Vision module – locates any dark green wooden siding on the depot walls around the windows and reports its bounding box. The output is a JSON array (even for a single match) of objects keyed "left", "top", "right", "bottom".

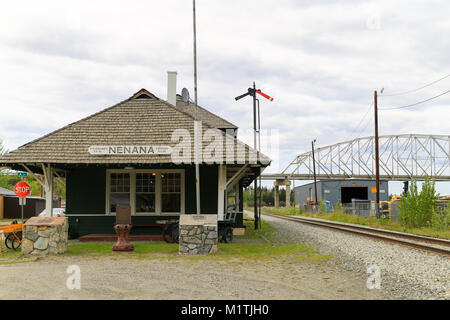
[{"left": 66, "top": 165, "right": 244, "bottom": 238}]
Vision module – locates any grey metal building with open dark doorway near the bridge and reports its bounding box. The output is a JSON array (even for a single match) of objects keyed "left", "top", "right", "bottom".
[{"left": 294, "top": 179, "right": 389, "bottom": 207}]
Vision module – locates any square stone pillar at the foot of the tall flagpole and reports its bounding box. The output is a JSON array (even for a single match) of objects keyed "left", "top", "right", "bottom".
[{"left": 179, "top": 214, "right": 219, "bottom": 255}]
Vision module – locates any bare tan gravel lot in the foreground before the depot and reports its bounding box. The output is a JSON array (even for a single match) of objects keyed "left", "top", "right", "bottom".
[{"left": 0, "top": 253, "right": 383, "bottom": 300}]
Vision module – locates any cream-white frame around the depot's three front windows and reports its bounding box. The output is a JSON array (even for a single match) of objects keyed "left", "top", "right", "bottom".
[{"left": 105, "top": 169, "right": 185, "bottom": 216}]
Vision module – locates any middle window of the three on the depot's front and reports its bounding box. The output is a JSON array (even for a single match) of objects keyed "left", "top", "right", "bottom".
[{"left": 136, "top": 172, "right": 156, "bottom": 212}]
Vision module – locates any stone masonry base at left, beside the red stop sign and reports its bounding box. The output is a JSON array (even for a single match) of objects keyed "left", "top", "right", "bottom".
[{"left": 22, "top": 217, "right": 69, "bottom": 255}]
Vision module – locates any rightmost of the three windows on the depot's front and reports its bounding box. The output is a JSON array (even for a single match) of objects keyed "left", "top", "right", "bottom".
[{"left": 161, "top": 173, "right": 181, "bottom": 212}]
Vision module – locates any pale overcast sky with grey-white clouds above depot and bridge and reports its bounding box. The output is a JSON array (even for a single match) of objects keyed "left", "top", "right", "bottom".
[{"left": 0, "top": 0, "right": 450, "bottom": 193}]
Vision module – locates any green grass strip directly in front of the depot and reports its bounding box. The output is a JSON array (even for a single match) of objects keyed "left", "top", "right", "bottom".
[{"left": 0, "top": 219, "right": 331, "bottom": 264}]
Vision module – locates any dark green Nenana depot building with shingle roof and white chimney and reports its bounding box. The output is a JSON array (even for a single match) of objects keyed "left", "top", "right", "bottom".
[{"left": 0, "top": 72, "right": 270, "bottom": 238}]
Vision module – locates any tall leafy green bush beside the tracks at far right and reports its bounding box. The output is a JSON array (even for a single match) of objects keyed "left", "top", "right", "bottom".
[{"left": 399, "top": 178, "right": 439, "bottom": 228}]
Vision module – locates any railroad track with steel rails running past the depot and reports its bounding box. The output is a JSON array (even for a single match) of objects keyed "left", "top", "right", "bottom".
[{"left": 261, "top": 212, "right": 450, "bottom": 256}]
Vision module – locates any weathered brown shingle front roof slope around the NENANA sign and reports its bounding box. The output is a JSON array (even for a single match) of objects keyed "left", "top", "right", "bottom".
[{"left": 0, "top": 89, "right": 270, "bottom": 166}]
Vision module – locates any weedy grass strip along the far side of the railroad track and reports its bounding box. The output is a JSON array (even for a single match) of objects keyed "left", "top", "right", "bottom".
[{"left": 263, "top": 208, "right": 450, "bottom": 239}]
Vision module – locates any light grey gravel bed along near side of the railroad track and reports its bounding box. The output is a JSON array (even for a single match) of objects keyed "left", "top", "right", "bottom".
[{"left": 263, "top": 212, "right": 450, "bottom": 300}]
